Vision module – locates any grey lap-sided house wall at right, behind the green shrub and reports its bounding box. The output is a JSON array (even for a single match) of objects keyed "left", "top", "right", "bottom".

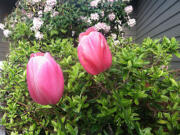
[{"left": 136, "top": 0, "right": 180, "bottom": 69}]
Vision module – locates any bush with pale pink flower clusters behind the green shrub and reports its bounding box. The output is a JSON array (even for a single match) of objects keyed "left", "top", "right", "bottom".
[{"left": 0, "top": 0, "right": 136, "bottom": 43}]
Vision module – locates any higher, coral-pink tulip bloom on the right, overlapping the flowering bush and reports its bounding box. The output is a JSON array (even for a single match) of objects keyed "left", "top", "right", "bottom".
[{"left": 78, "top": 27, "right": 112, "bottom": 75}]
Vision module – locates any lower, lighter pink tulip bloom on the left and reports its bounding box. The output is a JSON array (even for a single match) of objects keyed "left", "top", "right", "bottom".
[{"left": 27, "top": 52, "right": 64, "bottom": 105}]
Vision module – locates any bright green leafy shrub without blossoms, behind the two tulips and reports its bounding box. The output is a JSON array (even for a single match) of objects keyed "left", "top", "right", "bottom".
[{"left": 0, "top": 38, "right": 180, "bottom": 135}]
